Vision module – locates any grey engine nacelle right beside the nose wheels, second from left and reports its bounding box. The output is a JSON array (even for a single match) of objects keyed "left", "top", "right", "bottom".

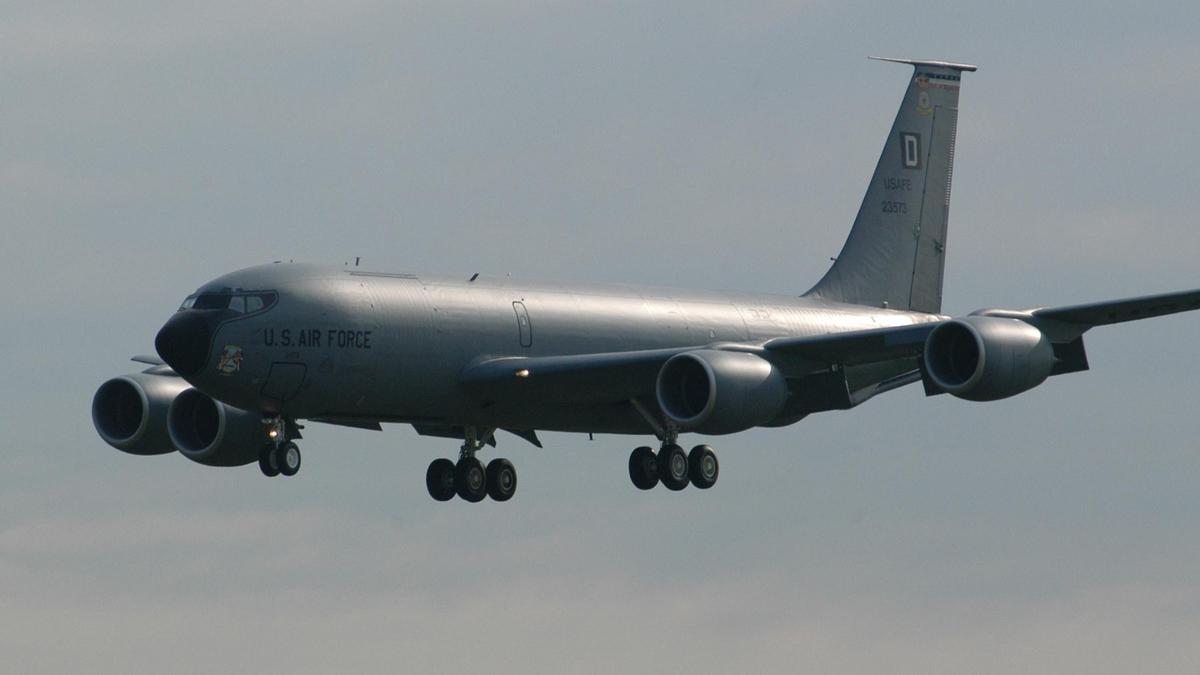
[{"left": 167, "top": 389, "right": 269, "bottom": 466}]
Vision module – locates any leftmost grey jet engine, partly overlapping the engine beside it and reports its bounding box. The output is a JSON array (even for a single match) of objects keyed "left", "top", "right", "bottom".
[{"left": 91, "top": 369, "right": 187, "bottom": 455}]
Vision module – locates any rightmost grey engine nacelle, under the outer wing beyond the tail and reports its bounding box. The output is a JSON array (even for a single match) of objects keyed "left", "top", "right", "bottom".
[{"left": 925, "top": 316, "right": 1055, "bottom": 401}]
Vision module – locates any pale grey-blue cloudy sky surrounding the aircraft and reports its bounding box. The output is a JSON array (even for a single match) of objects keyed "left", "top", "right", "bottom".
[{"left": 0, "top": 0, "right": 1200, "bottom": 674}]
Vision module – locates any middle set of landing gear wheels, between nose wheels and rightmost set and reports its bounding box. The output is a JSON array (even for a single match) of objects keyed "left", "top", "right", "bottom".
[{"left": 425, "top": 426, "right": 517, "bottom": 502}]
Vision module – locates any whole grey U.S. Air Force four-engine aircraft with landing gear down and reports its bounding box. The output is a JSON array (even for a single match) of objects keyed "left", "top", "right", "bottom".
[{"left": 92, "top": 59, "right": 1200, "bottom": 502}]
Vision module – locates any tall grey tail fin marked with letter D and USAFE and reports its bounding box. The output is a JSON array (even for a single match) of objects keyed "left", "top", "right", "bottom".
[{"left": 806, "top": 59, "right": 976, "bottom": 312}]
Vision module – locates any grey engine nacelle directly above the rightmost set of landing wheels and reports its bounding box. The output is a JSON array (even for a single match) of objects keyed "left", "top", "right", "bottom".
[{"left": 655, "top": 350, "right": 787, "bottom": 434}]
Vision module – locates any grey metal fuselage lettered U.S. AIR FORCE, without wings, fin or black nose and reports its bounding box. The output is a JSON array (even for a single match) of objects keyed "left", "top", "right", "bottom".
[{"left": 169, "top": 263, "right": 944, "bottom": 434}]
